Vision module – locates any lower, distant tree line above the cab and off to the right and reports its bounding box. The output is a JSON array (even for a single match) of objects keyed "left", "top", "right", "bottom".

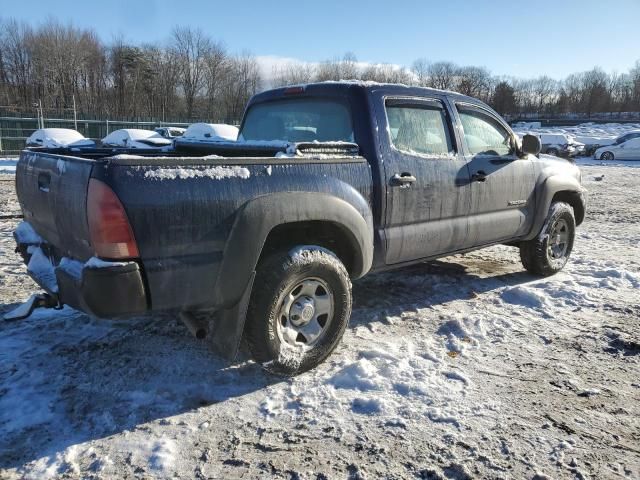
[{"left": 274, "top": 53, "right": 640, "bottom": 115}]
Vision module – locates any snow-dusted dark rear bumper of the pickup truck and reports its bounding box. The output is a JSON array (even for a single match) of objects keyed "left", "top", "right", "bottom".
[{"left": 16, "top": 234, "right": 148, "bottom": 318}]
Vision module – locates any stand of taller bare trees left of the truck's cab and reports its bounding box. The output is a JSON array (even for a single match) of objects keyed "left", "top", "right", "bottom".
[{"left": 0, "top": 19, "right": 262, "bottom": 121}]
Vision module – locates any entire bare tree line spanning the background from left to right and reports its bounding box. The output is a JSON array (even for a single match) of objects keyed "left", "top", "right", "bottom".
[{"left": 0, "top": 19, "right": 640, "bottom": 121}]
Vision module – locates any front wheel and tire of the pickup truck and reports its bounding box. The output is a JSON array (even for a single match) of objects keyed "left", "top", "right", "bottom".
[{"left": 520, "top": 202, "right": 576, "bottom": 277}]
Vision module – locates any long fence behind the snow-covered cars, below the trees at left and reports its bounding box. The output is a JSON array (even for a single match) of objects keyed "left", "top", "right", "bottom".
[{"left": 0, "top": 116, "right": 240, "bottom": 155}]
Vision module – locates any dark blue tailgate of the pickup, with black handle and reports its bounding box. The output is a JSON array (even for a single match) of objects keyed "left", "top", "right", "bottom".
[{"left": 16, "top": 150, "right": 99, "bottom": 260}]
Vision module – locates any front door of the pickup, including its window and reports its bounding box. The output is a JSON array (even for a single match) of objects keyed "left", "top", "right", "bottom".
[{"left": 456, "top": 103, "right": 536, "bottom": 247}]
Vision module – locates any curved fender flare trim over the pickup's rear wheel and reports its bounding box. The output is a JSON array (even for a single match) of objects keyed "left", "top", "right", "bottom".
[{"left": 215, "top": 192, "right": 373, "bottom": 308}]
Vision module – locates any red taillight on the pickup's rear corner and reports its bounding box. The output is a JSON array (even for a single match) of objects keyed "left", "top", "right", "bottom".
[{"left": 87, "top": 178, "right": 139, "bottom": 259}]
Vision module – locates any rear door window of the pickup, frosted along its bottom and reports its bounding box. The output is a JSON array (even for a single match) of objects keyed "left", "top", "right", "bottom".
[{"left": 386, "top": 103, "right": 455, "bottom": 156}]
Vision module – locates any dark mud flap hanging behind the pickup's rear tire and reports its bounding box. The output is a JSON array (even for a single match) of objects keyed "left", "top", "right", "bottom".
[{"left": 209, "top": 271, "right": 256, "bottom": 361}]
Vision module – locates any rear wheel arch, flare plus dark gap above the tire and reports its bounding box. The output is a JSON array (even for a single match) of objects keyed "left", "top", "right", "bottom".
[{"left": 215, "top": 192, "right": 373, "bottom": 308}]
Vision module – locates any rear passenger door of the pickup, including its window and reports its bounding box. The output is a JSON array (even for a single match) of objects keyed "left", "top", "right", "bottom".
[{"left": 380, "top": 97, "right": 471, "bottom": 264}]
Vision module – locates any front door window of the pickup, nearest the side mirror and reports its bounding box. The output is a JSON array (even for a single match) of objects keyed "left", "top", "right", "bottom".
[{"left": 458, "top": 106, "right": 513, "bottom": 156}]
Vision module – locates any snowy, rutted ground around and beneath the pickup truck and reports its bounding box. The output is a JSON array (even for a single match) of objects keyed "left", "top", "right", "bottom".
[{"left": 0, "top": 160, "right": 640, "bottom": 479}]
